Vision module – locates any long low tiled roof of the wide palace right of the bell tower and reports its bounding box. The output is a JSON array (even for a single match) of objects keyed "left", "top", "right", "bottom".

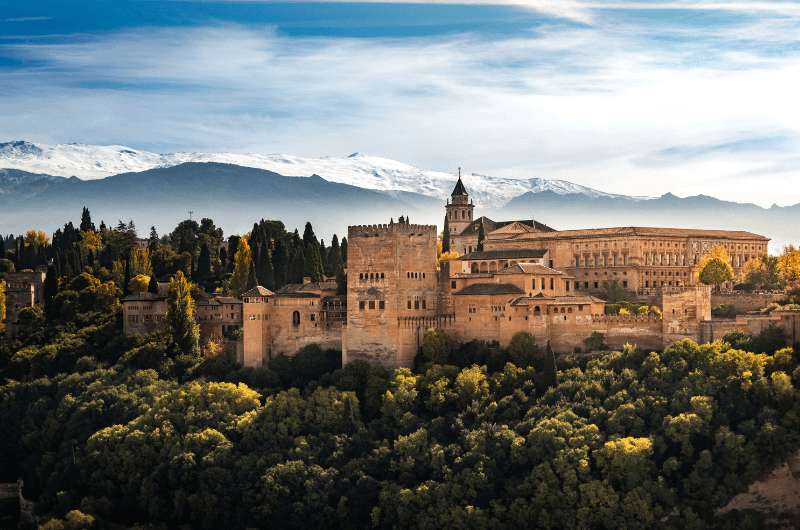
[{"left": 512, "top": 226, "right": 769, "bottom": 241}]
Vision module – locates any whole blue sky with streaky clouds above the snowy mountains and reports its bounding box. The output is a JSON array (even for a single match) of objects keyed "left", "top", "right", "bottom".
[{"left": 0, "top": 0, "right": 800, "bottom": 205}]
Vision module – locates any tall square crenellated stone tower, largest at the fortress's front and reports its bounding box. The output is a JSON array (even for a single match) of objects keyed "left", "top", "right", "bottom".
[{"left": 342, "top": 223, "right": 438, "bottom": 368}]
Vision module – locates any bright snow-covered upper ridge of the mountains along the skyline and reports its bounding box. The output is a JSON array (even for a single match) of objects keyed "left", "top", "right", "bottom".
[{"left": 0, "top": 141, "right": 640, "bottom": 207}]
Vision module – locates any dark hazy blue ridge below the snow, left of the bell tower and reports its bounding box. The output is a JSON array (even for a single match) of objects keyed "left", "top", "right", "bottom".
[{"left": 0, "top": 162, "right": 441, "bottom": 237}]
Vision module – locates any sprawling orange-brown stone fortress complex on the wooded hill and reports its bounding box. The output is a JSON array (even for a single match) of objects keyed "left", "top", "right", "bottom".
[{"left": 111, "top": 177, "right": 800, "bottom": 367}]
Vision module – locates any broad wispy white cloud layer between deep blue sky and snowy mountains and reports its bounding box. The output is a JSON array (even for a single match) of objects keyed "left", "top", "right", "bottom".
[{"left": 0, "top": 11, "right": 800, "bottom": 204}]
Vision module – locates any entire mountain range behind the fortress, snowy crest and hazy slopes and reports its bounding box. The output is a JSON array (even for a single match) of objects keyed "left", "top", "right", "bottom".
[{"left": 0, "top": 141, "right": 800, "bottom": 251}]
